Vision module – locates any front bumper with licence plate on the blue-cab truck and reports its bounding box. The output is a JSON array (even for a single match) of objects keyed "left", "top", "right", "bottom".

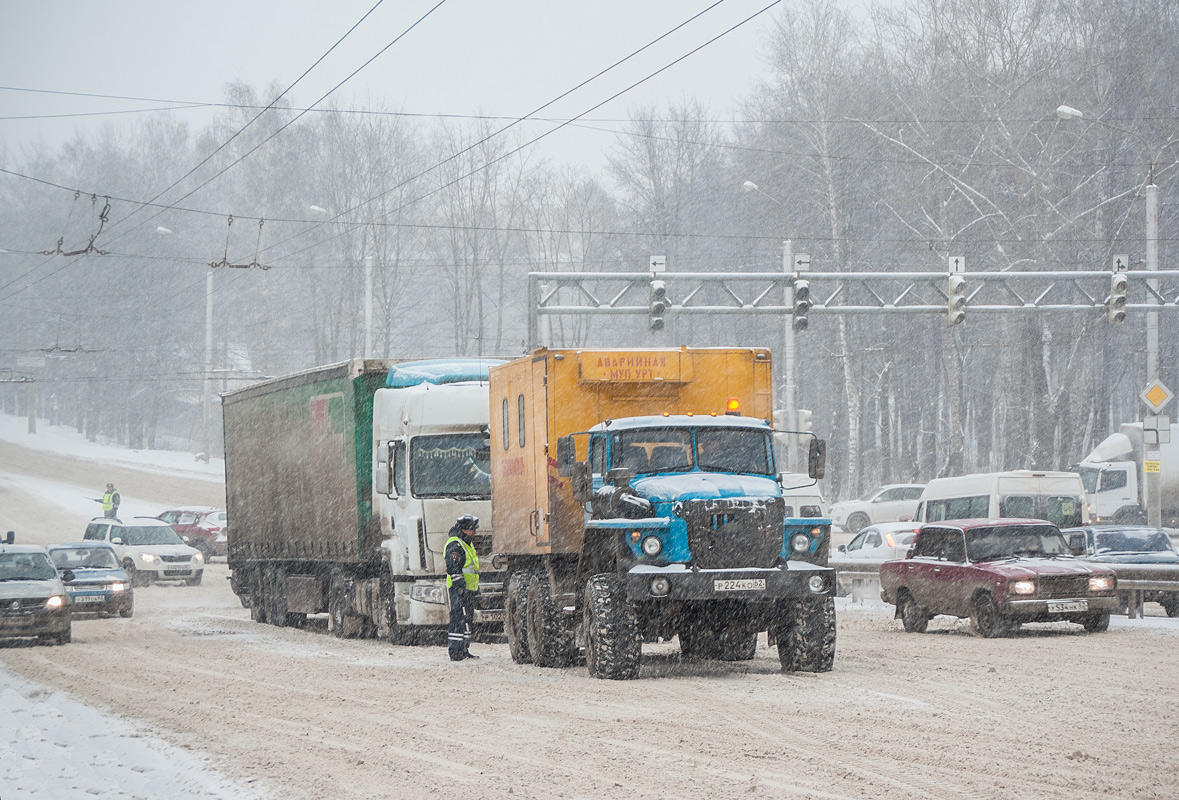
[{"left": 626, "top": 561, "right": 835, "bottom": 602}]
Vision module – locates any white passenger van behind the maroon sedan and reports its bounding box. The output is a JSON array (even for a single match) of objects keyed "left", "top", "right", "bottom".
[{"left": 914, "top": 469, "right": 1089, "bottom": 528}]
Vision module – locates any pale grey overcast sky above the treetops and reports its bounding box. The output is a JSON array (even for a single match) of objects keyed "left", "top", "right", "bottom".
[{"left": 0, "top": 0, "right": 788, "bottom": 166}]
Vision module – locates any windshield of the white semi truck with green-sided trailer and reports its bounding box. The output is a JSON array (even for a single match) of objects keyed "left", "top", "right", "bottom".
[{"left": 409, "top": 432, "right": 492, "bottom": 500}]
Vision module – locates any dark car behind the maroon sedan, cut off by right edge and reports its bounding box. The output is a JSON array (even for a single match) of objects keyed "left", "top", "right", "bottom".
[{"left": 1063, "top": 525, "right": 1179, "bottom": 616}]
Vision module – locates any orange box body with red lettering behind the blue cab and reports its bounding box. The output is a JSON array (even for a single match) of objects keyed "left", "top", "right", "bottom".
[{"left": 490, "top": 348, "right": 773, "bottom": 555}]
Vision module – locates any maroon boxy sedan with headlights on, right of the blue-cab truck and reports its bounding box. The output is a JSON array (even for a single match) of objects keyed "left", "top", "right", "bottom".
[{"left": 881, "top": 518, "right": 1118, "bottom": 639}]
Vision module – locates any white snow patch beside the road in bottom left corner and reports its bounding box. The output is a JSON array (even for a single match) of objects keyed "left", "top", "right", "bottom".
[{"left": 0, "top": 668, "right": 259, "bottom": 800}]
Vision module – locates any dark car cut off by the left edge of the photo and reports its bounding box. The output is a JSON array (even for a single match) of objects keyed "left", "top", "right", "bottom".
[{"left": 0, "top": 531, "right": 73, "bottom": 644}]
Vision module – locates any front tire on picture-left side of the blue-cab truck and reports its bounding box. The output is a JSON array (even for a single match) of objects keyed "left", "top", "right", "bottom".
[{"left": 582, "top": 574, "right": 643, "bottom": 680}]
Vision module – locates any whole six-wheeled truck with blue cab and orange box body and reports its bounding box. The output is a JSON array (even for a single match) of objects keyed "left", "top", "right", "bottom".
[{"left": 490, "top": 348, "right": 836, "bottom": 679}]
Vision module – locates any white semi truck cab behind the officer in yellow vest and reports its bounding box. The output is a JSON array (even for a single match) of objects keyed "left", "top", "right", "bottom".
[{"left": 373, "top": 358, "right": 502, "bottom": 627}]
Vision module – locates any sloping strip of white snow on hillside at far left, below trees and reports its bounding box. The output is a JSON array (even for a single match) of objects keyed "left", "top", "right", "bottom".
[{"left": 0, "top": 414, "right": 225, "bottom": 483}]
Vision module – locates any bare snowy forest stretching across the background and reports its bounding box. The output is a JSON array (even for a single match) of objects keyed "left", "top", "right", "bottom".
[{"left": 0, "top": 0, "right": 1179, "bottom": 500}]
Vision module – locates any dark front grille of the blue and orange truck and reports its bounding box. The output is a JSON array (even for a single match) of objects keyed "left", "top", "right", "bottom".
[{"left": 680, "top": 497, "right": 783, "bottom": 569}]
